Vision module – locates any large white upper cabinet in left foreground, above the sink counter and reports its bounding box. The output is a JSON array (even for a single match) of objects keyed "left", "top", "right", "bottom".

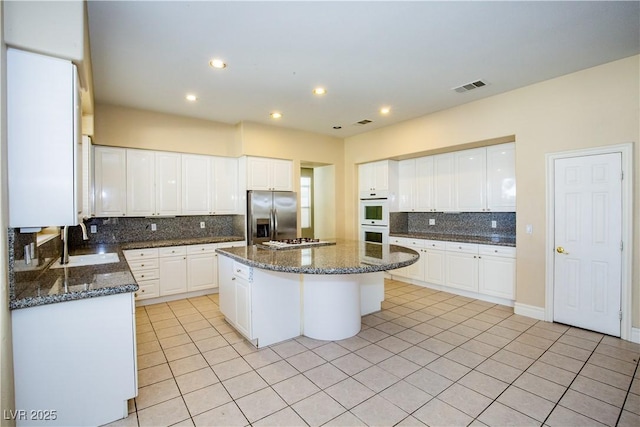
[{"left": 7, "top": 49, "right": 82, "bottom": 228}]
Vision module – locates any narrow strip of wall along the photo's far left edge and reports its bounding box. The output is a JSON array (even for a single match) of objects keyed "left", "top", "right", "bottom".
[{"left": 0, "top": 2, "right": 15, "bottom": 426}]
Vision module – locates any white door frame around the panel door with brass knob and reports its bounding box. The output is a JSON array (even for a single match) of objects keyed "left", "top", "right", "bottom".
[{"left": 544, "top": 142, "right": 634, "bottom": 341}]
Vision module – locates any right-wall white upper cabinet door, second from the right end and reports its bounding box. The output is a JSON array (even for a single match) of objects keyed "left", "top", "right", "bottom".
[{"left": 455, "top": 147, "right": 487, "bottom": 212}]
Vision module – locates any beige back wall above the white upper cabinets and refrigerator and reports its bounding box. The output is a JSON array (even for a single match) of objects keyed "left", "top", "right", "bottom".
[{"left": 93, "top": 104, "right": 345, "bottom": 236}]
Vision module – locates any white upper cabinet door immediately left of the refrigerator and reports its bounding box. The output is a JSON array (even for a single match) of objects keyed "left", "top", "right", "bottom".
[{"left": 211, "top": 157, "right": 239, "bottom": 214}]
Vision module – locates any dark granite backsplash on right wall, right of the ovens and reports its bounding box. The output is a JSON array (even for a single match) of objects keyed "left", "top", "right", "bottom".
[{"left": 389, "top": 212, "right": 516, "bottom": 237}]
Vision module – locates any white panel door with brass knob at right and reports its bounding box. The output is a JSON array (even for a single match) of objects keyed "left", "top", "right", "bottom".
[{"left": 553, "top": 153, "right": 622, "bottom": 337}]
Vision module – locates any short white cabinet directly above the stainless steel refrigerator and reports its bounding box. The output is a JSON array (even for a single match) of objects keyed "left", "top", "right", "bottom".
[{"left": 246, "top": 157, "right": 293, "bottom": 191}]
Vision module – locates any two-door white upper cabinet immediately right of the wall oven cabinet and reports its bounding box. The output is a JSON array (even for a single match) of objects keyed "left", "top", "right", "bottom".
[{"left": 398, "top": 156, "right": 435, "bottom": 212}]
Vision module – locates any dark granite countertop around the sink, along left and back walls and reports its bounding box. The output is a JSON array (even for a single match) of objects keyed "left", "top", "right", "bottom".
[{"left": 9, "top": 236, "right": 244, "bottom": 310}]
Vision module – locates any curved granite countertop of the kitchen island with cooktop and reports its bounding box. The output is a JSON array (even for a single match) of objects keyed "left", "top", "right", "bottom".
[{"left": 216, "top": 240, "right": 420, "bottom": 274}]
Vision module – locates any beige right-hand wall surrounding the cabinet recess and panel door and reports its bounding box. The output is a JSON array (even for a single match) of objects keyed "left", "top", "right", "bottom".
[{"left": 345, "top": 56, "right": 640, "bottom": 327}]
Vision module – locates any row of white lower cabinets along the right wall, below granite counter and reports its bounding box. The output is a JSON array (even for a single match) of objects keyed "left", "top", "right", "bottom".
[{"left": 389, "top": 237, "right": 516, "bottom": 302}]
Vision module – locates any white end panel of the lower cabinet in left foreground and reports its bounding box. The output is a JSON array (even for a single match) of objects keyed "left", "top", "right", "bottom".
[{"left": 11, "top": 293, "right": 138, "bottom": 426}]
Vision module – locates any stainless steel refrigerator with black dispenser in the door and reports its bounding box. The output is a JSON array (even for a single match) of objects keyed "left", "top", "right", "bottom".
[{"left": 247, "top": 190, "right": 298, "bottom": 246}]
